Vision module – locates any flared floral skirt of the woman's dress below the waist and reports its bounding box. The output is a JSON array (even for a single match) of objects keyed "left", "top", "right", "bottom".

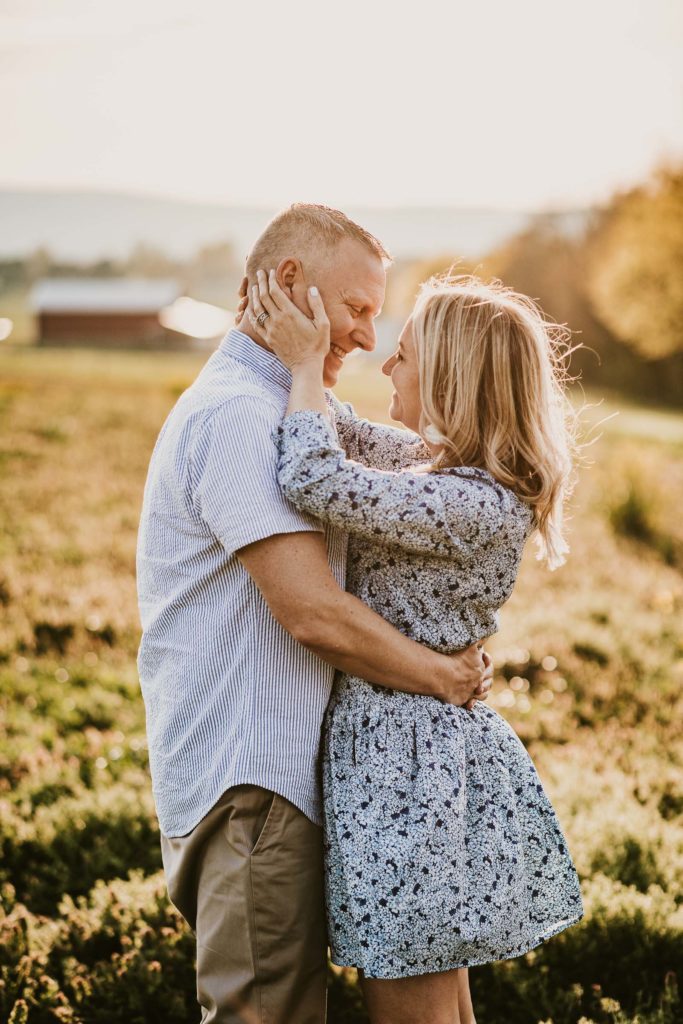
[{"left": 323, "top": 676, "right": 583, "bottom": 978}]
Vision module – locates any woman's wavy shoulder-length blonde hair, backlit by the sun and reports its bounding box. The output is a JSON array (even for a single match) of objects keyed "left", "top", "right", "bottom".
[{"left": 412, "top": 273, "right": 578, "bottom": 568}]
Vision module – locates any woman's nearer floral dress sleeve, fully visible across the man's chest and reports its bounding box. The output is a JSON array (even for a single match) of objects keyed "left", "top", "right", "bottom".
[{"left": 276, "top": 411, "right": 511, "bottom": 558}]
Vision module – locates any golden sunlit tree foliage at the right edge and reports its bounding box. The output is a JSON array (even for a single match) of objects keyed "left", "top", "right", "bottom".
[{"left": 587, "top": 167, "right": 683, "bottom": 359}]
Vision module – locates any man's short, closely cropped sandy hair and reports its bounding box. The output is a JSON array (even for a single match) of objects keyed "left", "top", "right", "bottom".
[{"left": 247, "top": 203, "right": 391, "bottom": 278}]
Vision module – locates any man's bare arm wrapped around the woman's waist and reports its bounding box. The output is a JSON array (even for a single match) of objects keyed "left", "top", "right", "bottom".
[{"left": 238, "top": 532, "right": 493, "bottom": 705}]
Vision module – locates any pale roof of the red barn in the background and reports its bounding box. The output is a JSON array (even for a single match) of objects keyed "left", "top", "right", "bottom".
[{"left": 31, "top": 278, "right": 180, "bottom": 313}]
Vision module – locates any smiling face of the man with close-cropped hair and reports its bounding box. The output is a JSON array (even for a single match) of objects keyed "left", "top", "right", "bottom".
[{"left": 292, "top": 239, "right": 386, "bottom": 387}]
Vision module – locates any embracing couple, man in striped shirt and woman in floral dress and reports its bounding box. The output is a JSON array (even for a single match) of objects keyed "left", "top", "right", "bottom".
[{"left": 137, "top": 204, "right": 583, "bottom": 1024}]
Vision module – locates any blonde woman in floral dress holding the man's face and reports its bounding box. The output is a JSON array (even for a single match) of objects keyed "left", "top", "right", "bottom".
[{"left": 251, "top": 272, "right": 583, "bottom": 1024}]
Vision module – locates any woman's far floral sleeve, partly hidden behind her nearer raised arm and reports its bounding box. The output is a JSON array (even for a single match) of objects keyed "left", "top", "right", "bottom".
[{"left": 328, "top": 391, "right": 430, "bottom": 470}]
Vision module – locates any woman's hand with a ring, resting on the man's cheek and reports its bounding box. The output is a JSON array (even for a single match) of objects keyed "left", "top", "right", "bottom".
[{"left": 248, "top": 270, "right": 330, "bottom": 375}]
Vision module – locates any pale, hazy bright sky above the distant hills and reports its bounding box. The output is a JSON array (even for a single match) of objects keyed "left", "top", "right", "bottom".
[{"left": 0, "top": 0, "right": 683, "bottom": 210}]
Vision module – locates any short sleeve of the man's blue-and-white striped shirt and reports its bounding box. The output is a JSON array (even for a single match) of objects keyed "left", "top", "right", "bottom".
[{"left": 190, "top": 395, "right": 323, "bottom": 554}]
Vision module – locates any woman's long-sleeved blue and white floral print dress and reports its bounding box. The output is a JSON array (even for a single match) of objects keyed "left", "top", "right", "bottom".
[{"left": 276, "top": 402, "right": 583, "bottom": 978}]
